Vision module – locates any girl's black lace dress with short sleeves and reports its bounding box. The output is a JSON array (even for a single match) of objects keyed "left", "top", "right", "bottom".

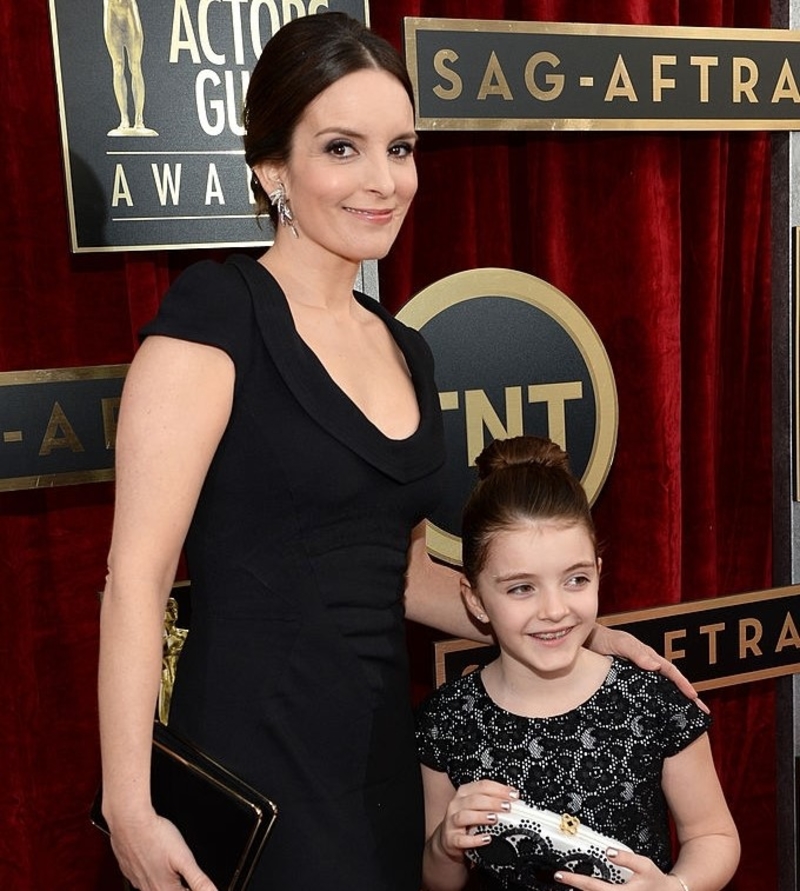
[{"left": 417, "top": 659, "right": 710, "bottom": 891}]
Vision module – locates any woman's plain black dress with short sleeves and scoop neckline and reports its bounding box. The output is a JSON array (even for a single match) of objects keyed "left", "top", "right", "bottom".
[{"left": 142, "top": 255, "right": 444, "bottom": 891}]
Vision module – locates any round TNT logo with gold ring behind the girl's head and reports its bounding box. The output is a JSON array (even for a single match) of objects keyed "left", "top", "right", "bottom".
[{"left": 397, "top": 269, "right": 617, "bottom": 564}]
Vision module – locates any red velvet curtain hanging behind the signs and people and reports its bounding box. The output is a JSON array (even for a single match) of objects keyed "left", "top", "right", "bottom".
[{"left": 0, "top": 0, "right": 777, "bottom": 891}]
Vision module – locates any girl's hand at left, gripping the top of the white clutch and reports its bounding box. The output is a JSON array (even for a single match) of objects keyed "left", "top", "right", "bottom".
[{"left": 432, "top": 780, "right": 519, "bottom": 862}]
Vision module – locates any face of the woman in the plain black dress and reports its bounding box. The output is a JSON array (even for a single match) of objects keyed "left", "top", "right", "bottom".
[{"left": 262, "top": 69, "right": 417, "bottom": 262}]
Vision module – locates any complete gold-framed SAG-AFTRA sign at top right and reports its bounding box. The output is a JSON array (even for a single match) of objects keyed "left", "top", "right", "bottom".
[{"left": 405, "top": 18, "right": 800, "bottom": 130}]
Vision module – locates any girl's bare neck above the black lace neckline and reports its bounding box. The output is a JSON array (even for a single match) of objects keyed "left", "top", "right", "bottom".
[{"left": 481, "top": 648, "right": 611, "bottom": 718}]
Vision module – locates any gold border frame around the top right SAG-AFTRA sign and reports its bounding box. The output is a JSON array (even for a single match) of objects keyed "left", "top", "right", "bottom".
[{"left": 403, "top": 16, "right": 800, "bottom": 131}]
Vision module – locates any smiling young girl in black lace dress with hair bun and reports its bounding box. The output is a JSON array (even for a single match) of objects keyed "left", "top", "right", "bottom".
[{"left": 417, "top": 436, "right": 739, "bottom": 891}]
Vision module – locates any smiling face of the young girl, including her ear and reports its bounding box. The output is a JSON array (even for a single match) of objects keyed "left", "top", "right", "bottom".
[{"left": 462, "top": 522, "right": 600, "bottom": 677}]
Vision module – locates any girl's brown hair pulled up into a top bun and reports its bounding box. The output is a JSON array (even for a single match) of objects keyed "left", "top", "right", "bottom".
[{"left": 461, "top": 436, "right": 597, "bottom": 585}]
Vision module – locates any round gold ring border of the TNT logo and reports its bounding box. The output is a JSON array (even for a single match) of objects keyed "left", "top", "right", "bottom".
[{"left": 397, "top": 267, "right": 619, "bottom": 564}]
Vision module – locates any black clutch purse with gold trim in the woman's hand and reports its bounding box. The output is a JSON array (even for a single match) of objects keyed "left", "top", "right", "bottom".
[{"left": 91, "top": 722, "right": 278, "bottom": 891}]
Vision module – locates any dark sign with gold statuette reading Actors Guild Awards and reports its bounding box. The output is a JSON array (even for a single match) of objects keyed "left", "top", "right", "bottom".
[{"left": 50, "top": 0, "right": 369, "bottom": 252}]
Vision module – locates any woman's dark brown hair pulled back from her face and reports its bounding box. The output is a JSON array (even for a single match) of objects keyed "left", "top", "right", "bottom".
[{"left": 243, "top": 12, "right": 414, "bottom": 225}]
